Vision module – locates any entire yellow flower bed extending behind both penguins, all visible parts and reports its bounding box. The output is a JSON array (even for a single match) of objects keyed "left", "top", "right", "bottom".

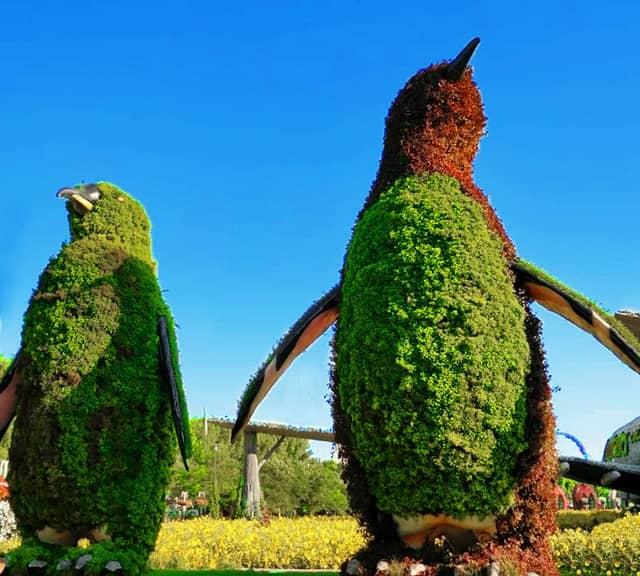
[{"left": 0, "top": 515, "right": 640, "bottom": 576}]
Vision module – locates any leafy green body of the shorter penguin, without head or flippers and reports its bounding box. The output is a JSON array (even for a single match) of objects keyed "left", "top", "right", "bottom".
[{"left": 10, "top": 239, "right": 175, "bottom": 550}]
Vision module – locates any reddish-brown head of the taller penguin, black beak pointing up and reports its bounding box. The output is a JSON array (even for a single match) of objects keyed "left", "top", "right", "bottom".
[{"left": 380, "top": 38, "right": 486, "bottom": 194}]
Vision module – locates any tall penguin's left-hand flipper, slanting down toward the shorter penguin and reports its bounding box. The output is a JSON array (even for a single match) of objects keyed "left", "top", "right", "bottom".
[{"left": 231, "top": 285, "right": 340, "bottom": 440}]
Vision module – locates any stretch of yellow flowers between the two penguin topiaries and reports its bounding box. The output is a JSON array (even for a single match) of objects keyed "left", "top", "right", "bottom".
[{"left": 151, "top": 516, "right": 366, "bottom": 570}]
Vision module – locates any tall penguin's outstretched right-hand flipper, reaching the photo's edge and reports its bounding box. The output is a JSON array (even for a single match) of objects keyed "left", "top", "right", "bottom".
[{"left": 511, "top": 260, "right": 640, "bottom": 374}]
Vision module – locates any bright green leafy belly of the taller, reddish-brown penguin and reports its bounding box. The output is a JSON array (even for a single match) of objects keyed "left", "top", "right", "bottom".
[{"left": 335, "top": 174, "right": 529, "bottom": 516}]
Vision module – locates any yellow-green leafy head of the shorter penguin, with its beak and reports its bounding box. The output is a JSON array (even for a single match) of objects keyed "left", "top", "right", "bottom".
[{"left": 57, "top": 182, "right": 151, "bottom": 251}]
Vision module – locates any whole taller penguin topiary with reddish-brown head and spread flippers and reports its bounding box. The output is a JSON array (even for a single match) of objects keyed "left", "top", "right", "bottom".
[{"left": 233, "top": 39, "right": 640, "bottom": 576}]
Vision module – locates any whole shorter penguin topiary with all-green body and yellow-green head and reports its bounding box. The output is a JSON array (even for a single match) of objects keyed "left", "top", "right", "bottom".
[{"left": 2, "top": 182, "right": 190, "bottom": 574}]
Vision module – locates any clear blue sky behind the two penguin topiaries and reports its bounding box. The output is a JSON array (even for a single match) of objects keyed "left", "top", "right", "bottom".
[{"left": 0, "top": 0, "right": 640, "bottom": 456}]
